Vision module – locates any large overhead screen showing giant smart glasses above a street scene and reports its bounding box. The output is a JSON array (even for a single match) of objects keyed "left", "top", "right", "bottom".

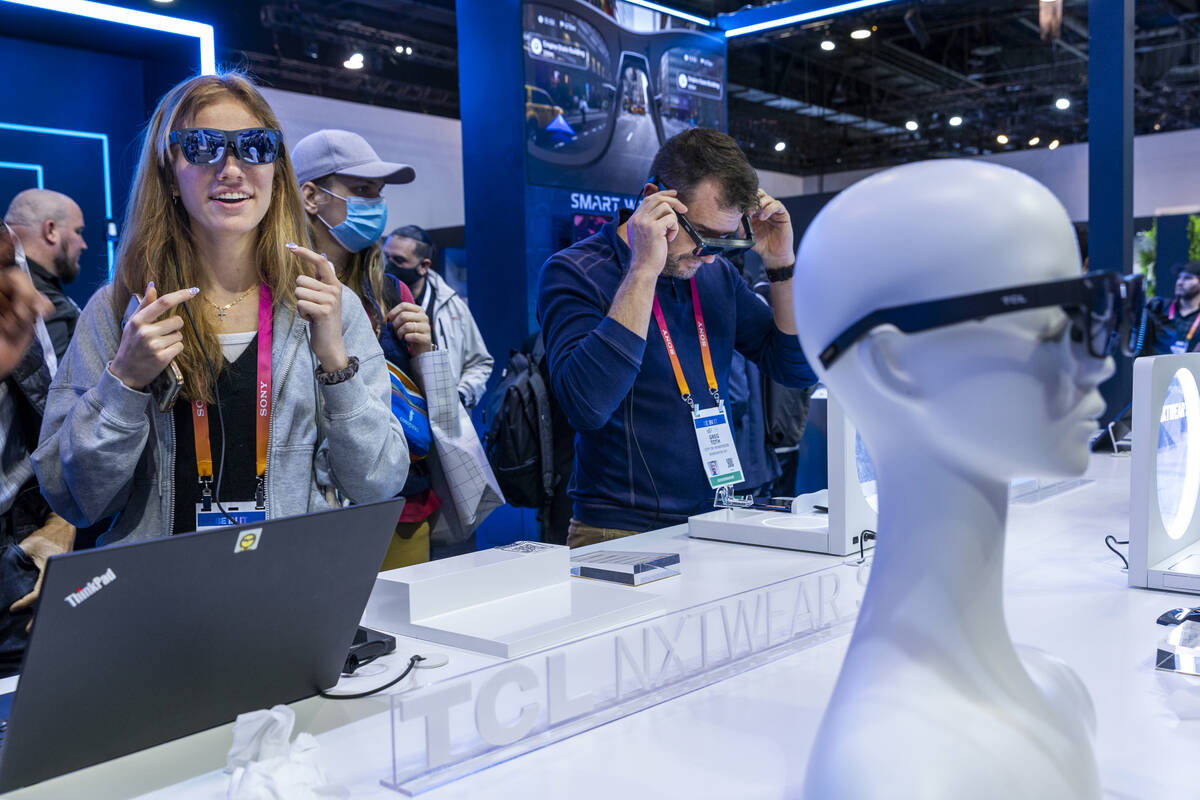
[{"left": 523, "top": 0, "right": 725, "bottom": 194}]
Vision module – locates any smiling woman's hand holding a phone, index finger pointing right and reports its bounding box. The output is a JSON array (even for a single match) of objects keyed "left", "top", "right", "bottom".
[{"left": 108, "top": 282, "right": 199, "bottom": 391}]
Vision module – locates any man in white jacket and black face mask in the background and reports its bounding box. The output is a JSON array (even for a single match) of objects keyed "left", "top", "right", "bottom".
[{"left": 383, "top": 225, "right": 494, "bottom": 409}]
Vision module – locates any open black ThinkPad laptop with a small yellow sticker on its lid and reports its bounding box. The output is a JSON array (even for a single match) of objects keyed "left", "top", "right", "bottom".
[{"left": 0, "top": 500, "right": 403, "bottom": 792}]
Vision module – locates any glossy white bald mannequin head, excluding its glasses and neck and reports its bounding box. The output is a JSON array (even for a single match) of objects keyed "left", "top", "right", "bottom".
[{"left": 794, "top": 160, "right": 1112, "bottom": 481}]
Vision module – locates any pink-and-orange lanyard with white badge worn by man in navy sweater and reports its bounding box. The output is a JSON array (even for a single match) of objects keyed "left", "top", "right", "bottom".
[{"left": 654, "top": 278, "right": 743, "bottom": 489}]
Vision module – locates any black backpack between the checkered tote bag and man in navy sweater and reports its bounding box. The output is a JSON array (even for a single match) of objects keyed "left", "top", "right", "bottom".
[{"left": 484, "top": 333, "right": 556, "bottom": 509}]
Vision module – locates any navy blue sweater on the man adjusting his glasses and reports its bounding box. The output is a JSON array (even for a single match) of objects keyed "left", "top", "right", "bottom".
[{"left": 538, "top": 211, "right": 816, "bottom": 530}]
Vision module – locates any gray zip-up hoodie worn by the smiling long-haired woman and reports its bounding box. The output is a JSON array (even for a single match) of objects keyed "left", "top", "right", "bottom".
[{"left": 34, "top": 285, "right": 408, "bottom": 545}]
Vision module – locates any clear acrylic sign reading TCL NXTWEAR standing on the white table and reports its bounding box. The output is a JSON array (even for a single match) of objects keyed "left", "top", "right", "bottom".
[{"left": 383, "top": 564, "right": 866, "bottom": 795}]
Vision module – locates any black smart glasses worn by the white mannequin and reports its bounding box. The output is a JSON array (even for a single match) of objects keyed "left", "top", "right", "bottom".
[{"left": 821, "top": 272, "right": 1146, "bottom": 369}]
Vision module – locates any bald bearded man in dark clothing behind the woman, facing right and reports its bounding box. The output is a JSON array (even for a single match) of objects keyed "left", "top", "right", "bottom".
[{"left": 4, "top": 188, "right": 88, "bottom": 359}]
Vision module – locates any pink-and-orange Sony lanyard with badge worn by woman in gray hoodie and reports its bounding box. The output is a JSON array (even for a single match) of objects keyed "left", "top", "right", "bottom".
[{"left": 192, "top": 284, "right": 272, "bottom": 530}]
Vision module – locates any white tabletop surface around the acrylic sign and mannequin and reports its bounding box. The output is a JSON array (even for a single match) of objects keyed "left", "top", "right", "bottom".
[{"left": 4, "top": 456, "right": 1200, "bottom": 800}]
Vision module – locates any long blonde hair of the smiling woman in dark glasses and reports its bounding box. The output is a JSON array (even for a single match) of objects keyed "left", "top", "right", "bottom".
[{"left": 113, "top": 72, "right": 312, "bottom": 402}]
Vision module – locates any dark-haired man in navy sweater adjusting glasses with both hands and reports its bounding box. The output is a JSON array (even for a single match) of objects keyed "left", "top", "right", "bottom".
[{"left": 538, "top": 128, "right": 815, "bottom": 546}]
